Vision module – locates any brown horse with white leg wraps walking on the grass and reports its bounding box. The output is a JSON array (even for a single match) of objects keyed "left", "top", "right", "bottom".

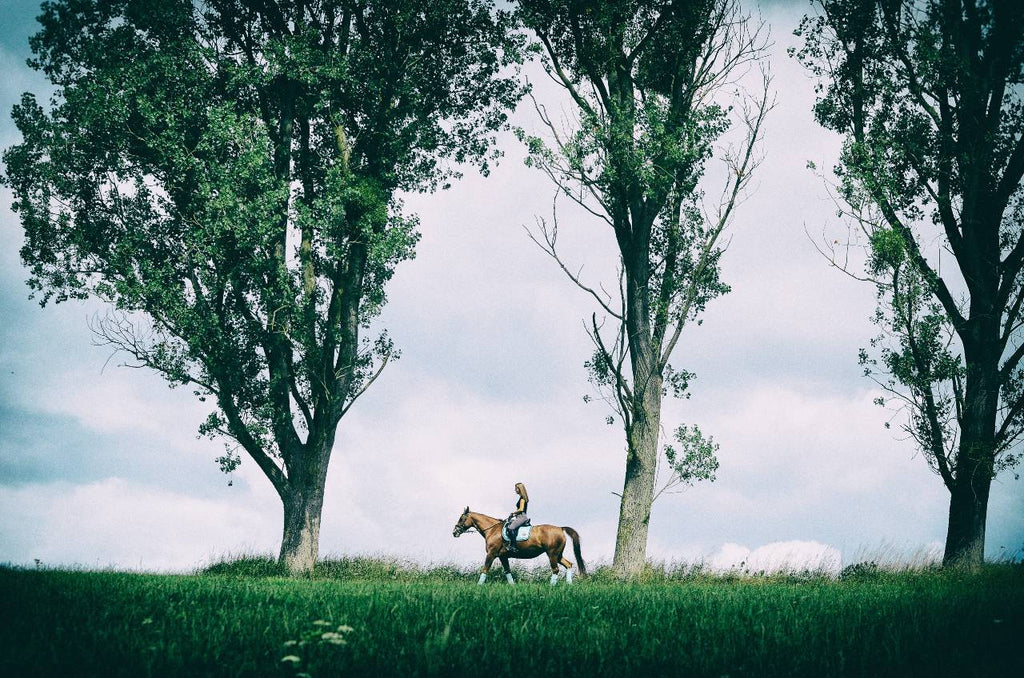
[{"left": 452, "top": 506, "right": 587, "bottom": 586}]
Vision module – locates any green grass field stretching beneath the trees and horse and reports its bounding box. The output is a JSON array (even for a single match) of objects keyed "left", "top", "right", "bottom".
[{"left": 0, "top": 559, "right": 1024, "bottom": 678}]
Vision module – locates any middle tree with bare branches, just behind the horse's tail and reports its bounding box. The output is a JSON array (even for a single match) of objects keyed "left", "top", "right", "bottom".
[{"left": 519, "top": 0, "right": 770, "bottom": 575}]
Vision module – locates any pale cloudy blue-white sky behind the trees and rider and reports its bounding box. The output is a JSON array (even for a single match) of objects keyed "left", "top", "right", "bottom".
[{"left": 0, "top": 0, "right": 1024, "bottom": 571}]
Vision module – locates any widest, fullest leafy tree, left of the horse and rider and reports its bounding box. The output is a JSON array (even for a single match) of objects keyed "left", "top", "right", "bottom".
[{"left": 4, "top": 0, "right": 522, "bottom": 571}]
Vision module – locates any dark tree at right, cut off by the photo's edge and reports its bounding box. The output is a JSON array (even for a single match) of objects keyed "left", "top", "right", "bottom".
[{"left": 798, "top": 0, "right": 1024, "bottom": 564}]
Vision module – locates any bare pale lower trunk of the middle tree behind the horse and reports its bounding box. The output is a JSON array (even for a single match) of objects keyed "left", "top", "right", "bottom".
[{"left": 612, "top": 379, "right": 662, "bottom": 577}]
